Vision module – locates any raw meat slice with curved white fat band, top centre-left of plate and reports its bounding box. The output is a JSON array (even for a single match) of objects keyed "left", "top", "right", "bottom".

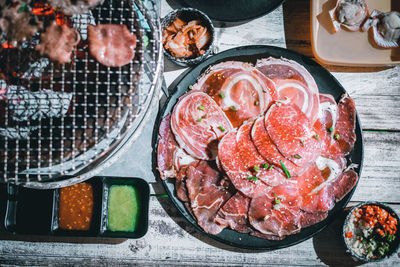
[{"left": 193, "top": 61, "right": 278, "bottom": 127}]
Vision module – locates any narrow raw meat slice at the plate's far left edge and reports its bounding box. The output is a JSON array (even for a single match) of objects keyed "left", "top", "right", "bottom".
[{"left": 157, "top": 115, "right": 195, "bottom": 180}]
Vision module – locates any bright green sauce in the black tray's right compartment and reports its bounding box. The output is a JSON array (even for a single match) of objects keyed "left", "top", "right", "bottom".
[{"left": 108, "top": 185, "right": 139, "bottom": 232}]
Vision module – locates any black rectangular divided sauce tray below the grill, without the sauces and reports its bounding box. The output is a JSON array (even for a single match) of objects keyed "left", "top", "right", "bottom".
[{"left": 0, "top": 177, "right": 150, "bottom": 239}]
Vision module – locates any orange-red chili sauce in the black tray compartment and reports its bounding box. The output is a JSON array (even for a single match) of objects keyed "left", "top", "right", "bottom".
[{"left": 58, "top": 183, "right": 93, "bottom": 230}]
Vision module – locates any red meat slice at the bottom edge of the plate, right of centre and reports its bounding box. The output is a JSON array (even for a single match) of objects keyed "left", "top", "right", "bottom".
[{"left": 249, "top": 182, "right": 301, "bottom": 237}]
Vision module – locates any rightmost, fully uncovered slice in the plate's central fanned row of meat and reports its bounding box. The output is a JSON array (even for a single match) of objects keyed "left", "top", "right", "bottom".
[{"left": 265, "top": 102, "right": 321, "bottom": 166}]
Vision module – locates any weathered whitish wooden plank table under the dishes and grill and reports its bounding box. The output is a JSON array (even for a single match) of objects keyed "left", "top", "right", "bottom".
[{"left": 0, "top": 0, "right": 400, "bottom": 266}]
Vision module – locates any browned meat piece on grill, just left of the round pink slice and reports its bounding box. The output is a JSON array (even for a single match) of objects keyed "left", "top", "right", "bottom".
[{"left": 35, "top": 21, "right": 81, "bottom": 64}]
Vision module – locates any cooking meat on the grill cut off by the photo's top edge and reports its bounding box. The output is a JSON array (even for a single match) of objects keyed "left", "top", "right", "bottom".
[{"left": 48, "top": 0, "right": 103, "bottom": 15}]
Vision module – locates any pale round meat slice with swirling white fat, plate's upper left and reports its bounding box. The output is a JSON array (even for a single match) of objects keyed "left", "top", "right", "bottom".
[{"left": 171, "top": 91, "right": 232, "bottom": 160}]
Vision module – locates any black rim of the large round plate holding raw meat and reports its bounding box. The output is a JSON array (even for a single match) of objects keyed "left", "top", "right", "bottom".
[{"left": 152, "top": 45, "right": 364, "bottom": 251}]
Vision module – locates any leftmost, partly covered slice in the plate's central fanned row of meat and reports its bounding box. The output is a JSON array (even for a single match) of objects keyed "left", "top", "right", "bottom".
[{"left": 218, "top": 130, "right": 271, "bottom": 198}]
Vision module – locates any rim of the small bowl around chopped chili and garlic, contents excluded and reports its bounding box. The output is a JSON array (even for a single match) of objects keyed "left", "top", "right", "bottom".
[{"left": 342, "top": 201, "right": 400, "bottom": 262}]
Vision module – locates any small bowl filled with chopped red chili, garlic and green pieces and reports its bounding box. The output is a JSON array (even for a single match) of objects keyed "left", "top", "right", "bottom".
[{"left": 343, "top": 201, "right": 400, "bottom": 262}]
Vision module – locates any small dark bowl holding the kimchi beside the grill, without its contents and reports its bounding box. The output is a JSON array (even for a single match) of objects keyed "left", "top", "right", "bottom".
[{"left": 161, "top": 8, "right": 215, "bottom": 67}]
